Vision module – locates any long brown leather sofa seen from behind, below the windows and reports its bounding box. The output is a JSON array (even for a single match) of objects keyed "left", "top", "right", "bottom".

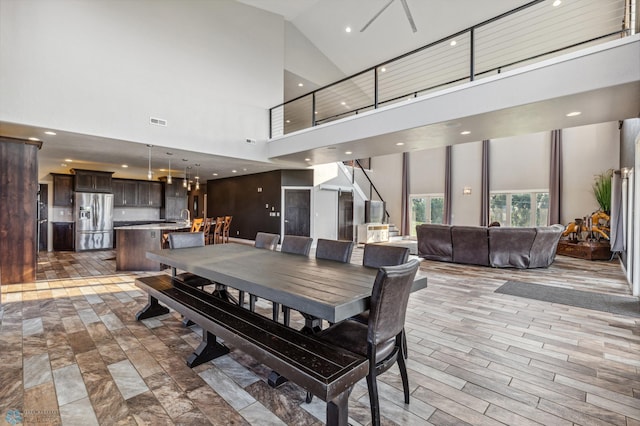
[{"left": 416, "top": 224, "right": 564, "bottom": 269}]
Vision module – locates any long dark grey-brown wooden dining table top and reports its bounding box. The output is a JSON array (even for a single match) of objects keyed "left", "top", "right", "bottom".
[{"left": 147, "top": 243, "right": 427, "bottom": 323}]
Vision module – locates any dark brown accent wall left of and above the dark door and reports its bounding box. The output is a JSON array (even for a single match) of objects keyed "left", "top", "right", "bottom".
[{"left": 207, "top": 170, "right": 313, "bottom": 240}]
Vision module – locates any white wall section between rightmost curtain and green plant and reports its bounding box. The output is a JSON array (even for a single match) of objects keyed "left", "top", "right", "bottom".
[{"left": 560, "top": 122, "right": 620, "bottom": 224}]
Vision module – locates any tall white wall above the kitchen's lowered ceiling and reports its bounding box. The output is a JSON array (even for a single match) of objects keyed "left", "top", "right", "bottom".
[{"left": 0, "top": 0, "right": 284, "bottom": 160}]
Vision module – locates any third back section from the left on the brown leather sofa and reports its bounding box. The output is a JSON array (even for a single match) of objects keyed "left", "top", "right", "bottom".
[{"left": 488, "top": 227, "right": 536, "bottom": 268}]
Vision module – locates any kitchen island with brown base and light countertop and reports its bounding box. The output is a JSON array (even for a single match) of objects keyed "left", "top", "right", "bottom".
[{"left": 114, "top": 222, "right": 191, "bottom": 271}]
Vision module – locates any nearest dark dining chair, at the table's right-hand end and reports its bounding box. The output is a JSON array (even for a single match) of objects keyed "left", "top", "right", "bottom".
[{"left": 316, "top": 259, "right": 420, "bottom": 425}]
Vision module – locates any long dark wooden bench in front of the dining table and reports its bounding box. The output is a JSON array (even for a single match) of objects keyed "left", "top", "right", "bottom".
[{"left": 136, "top": 275, "right": 369, "bottom": 425}]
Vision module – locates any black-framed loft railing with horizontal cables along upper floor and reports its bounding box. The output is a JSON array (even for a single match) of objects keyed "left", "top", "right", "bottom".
[{"left": 269, "top": 0, "right": 636, "bottom": 138}]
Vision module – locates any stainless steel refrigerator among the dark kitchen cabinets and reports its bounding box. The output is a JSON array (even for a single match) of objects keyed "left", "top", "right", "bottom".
[{"left": 73, "top": 192, "right": 113, "bottom": 251}]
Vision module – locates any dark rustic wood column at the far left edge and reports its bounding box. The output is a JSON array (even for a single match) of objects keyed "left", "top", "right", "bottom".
[{"left": 0, "top": 138, "right": 42, "bottom": 284}]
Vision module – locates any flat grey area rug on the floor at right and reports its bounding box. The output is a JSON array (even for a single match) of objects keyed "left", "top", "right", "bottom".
[{"left": 495, "top": 281, "right": 640, "bottom": 317}]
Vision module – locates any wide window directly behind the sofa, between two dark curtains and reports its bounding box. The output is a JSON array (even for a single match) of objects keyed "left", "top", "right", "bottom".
[{"left": 489, "top": 191, "right": 549, "bottom": 227}]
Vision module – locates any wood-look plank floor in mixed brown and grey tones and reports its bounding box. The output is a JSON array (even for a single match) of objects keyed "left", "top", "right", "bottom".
[{"left": 0, "top": 249, "right": 640, "bottom": 426}]
